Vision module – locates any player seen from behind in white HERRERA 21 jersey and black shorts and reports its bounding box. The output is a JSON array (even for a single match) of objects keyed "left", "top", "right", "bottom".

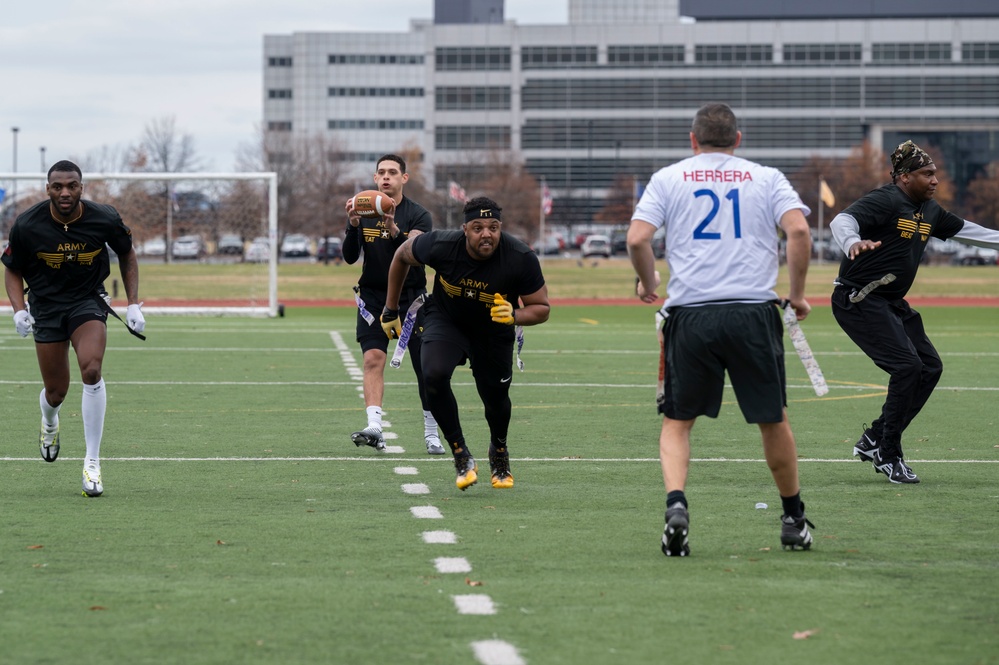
[{"left": 628, "top": 104, "right": 812, "bottom": 556}]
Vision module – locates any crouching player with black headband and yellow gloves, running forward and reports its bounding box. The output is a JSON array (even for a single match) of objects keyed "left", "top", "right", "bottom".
[{"left": 381, "top": 197, "right": 550, "bottom": 490}]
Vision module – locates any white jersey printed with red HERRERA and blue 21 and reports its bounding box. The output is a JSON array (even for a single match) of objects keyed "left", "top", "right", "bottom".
[{"left": 632, "top": 152, "right": 811, "bottom": 307}]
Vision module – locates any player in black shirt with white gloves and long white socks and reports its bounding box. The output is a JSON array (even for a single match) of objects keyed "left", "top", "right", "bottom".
[{"left": 0, "top": 160, "right": 146, "bottom": 496}]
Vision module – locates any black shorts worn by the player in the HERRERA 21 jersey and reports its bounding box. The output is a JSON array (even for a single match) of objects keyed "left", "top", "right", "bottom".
[{"left": 659, "top": 303, "right": 787, "bottom": 423}]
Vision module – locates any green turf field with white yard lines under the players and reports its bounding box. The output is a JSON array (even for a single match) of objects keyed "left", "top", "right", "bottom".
[{"left": 0, "top": 304, "right": 999, "bottom": 665}]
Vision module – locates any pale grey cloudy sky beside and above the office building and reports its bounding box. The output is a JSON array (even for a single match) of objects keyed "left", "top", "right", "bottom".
[{"left": 0, "top": 0, "right": 568, "bottom": 173}]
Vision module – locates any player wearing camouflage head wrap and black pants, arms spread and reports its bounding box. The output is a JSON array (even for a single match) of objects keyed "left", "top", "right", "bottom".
[{"left": 829, "top": 141, "right": 999, "bottom": 483}]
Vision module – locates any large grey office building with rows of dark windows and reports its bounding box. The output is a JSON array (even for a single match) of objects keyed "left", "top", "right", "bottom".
[{"left": 263, "top": 0, "right": 999, "bottom": 222}]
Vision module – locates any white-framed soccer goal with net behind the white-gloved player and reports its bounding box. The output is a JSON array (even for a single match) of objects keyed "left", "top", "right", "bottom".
[{"left": 0, "top": 172, "right": 281, "bottom": 317}]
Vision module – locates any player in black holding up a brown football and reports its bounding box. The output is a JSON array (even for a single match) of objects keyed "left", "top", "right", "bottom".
[{"left": 343, "top": 155, "right": 444, "bottom": 455}]
